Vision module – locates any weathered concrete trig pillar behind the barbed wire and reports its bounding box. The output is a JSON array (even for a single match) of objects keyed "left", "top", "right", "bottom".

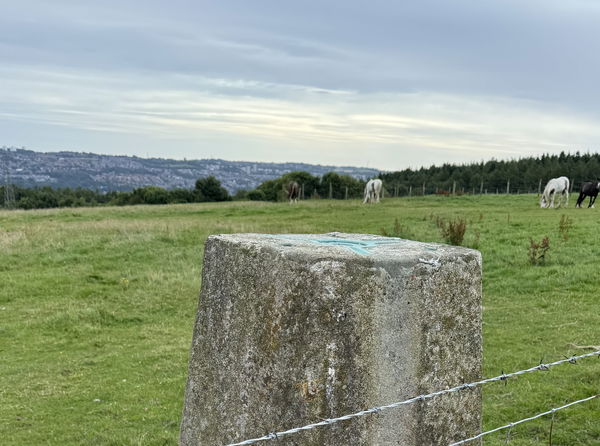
[{"left": 181, "top": 233, "right": 482, "bottom": 446}]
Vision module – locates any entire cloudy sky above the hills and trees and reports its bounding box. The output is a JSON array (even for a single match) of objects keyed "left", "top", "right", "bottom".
[{"left": 0, "top": 0, "right": 600, "bottom": 170}]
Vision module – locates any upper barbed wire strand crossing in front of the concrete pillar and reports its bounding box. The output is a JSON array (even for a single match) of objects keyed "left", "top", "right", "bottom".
[{"left": 226, "top": 350, "right": 600, "bottom": 446}]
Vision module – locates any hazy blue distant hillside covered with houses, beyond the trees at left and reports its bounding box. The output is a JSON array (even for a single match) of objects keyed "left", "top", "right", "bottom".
[{"left": 0, "top": 147, "right": 379, "bottom": 193}]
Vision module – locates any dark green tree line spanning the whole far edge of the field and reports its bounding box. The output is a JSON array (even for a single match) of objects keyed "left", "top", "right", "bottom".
[{"left": 0, "top": 152, "right": 600, "bottom": 209}]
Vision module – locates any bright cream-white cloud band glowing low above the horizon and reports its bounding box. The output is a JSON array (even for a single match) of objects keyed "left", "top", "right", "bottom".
[{"left": 0, "top": 65, "right": 600, "bottom": 169}]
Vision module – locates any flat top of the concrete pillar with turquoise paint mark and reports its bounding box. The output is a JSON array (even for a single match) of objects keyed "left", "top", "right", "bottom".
[{"left": 211, "top": 232, "right": 476, "bottom": 261}]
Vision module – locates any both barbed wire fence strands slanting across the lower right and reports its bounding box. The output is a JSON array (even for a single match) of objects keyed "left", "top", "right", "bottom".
[{"left": 226, "top": 350, "right": 600, "bottom": 446}]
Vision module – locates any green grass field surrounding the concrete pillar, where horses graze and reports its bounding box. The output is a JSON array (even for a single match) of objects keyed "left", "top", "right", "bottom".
[{"left": 0, "top": 195, "right": 600, "bottom": 445}]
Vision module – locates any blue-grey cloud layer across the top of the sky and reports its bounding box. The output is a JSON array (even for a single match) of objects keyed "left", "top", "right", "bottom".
[{"left": 5, "top": 1, "right": 600, "bottom": 99}]
